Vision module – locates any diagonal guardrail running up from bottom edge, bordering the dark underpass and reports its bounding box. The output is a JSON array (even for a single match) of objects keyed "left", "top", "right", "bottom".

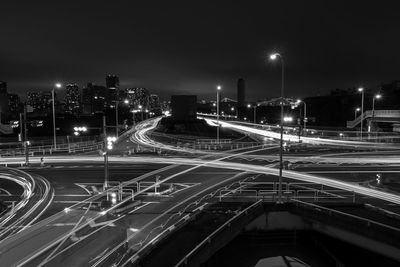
[{"left": 175, "top": 200, "right": 262, "bottom": 267}]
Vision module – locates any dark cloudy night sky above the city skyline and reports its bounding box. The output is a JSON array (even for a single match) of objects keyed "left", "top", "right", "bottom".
[{"left": 0, "top": 0, "right": 400, "bottom": 100}]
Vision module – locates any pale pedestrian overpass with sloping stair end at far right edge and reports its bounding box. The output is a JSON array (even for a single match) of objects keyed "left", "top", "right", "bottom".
[{"left": 347, "top": 110, "right": 400, "bottom": 130}]
